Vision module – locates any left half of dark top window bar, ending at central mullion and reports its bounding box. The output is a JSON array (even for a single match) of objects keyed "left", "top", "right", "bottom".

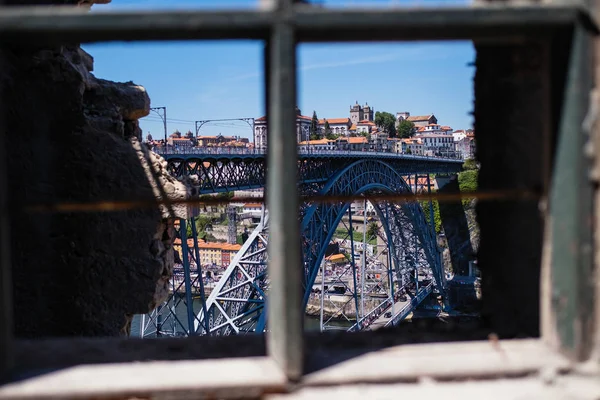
[{"left": 0, "top": 7, "right": 275, "bottom": 45}]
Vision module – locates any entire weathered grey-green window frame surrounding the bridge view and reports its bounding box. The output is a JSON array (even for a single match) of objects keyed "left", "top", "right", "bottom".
[{"left": 0, "top": 0, "right": 600, "bottom": 398}]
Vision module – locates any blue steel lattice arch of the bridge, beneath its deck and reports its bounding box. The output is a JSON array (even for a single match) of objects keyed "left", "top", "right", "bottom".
[{"left": 196, "top": 159, "right": 444, "bottom": 335}]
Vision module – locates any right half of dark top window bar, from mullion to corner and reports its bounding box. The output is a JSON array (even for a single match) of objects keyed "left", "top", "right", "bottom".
[{"left": 294, "top": 4, "right": 596, "bottom": 42}]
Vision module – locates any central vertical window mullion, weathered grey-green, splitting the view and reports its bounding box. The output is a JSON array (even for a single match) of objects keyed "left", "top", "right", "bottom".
[{"left": 265, "top": 4, "right": 304, "bottom": 380}]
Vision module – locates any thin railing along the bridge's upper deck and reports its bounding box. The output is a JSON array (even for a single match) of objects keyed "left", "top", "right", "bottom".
[{"left": 152, "top": 146, "right": 463, "bottom": 162}]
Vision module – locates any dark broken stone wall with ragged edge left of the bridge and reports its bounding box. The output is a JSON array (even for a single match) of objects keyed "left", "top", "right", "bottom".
[{"left": 0, "top": 0, "right": 187, "bottom": 337}]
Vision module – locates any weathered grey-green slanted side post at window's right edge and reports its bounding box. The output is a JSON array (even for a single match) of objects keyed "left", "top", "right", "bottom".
[{"left": 542, "top": 21, "right": 593, "bottom": 359}]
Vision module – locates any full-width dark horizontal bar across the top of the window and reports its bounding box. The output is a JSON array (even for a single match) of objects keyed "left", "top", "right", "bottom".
[{"left": 0, "top": 4, "right": 596, "bottom": 44}]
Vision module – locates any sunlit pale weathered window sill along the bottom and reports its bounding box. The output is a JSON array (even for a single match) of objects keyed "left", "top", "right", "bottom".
[{"left": 0, "top": 337, "right": 584, "bottom": 399}]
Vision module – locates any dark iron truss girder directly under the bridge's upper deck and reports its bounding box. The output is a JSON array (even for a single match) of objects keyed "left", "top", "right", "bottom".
[{"left": 163, "top": 152, "right": 462, "bottom": 194}]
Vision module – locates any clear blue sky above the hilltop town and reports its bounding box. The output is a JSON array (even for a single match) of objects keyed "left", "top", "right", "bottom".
[{"left": 82, "top": 0, "right": 475, "bottom": 141}]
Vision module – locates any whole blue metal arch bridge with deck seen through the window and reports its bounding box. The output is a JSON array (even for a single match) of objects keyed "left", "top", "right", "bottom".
[{"left": 140, "top": 148, "right": 462, "bottom": 337}]
